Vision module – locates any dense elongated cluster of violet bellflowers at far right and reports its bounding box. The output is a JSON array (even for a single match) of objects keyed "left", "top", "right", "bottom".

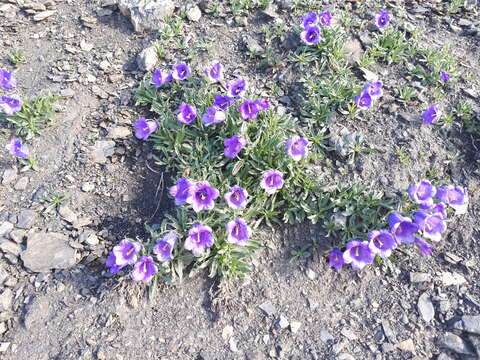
[{"left": 329, "top": 180, "right": 468, "bottom": 270}]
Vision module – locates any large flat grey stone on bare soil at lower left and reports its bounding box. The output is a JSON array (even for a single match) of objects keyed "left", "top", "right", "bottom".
[{"left": 20, "top": 232, "right": 76, "bottom": 272}]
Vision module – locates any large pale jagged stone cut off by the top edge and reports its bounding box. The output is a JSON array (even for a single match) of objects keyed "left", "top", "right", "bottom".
[{"left": 118, "top": 0, "right": 175, "bottom": 32}]
